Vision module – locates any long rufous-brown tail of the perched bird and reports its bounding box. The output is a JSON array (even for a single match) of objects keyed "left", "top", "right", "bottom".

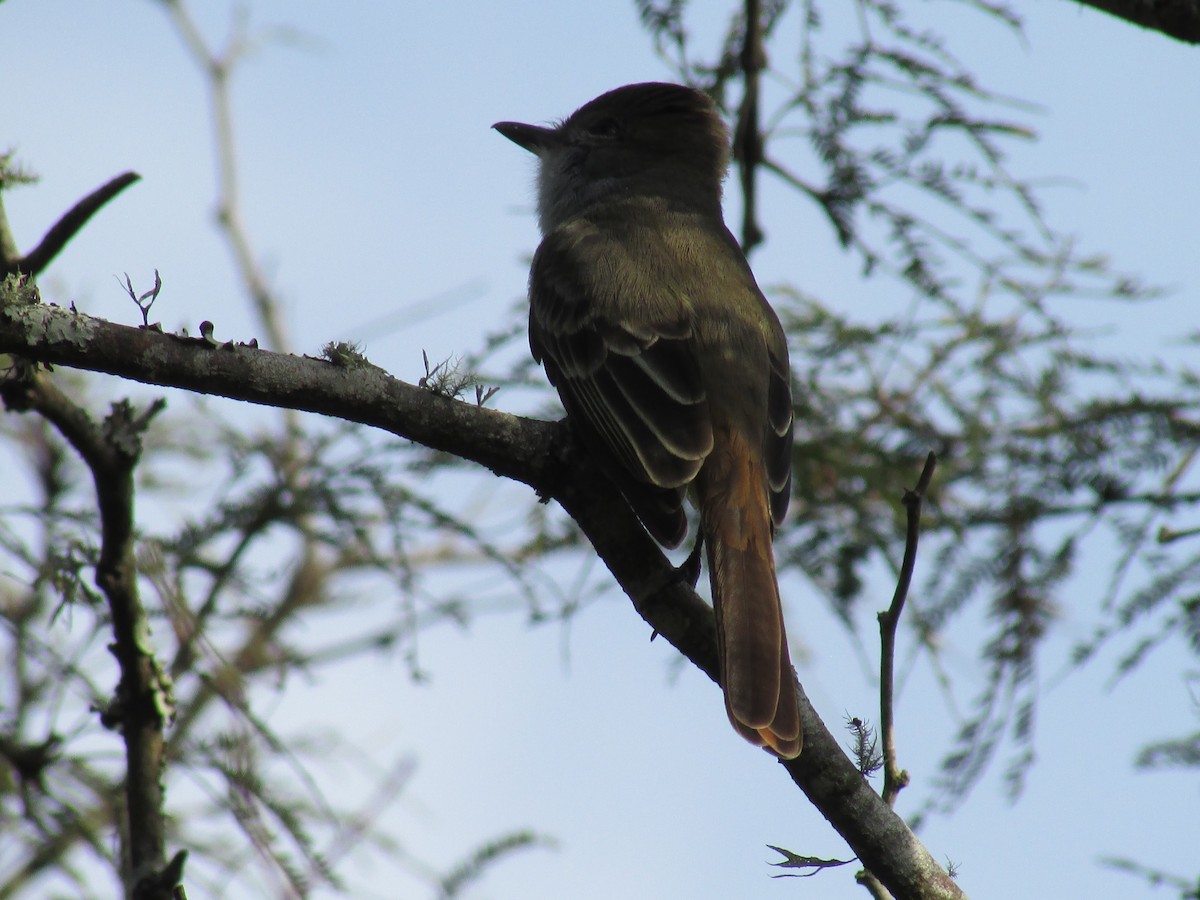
[{"left": 697, "top": 428, "right": 803, "bottom": 760}]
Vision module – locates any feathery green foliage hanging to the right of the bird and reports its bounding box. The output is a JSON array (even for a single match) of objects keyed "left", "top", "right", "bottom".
[{"left": 638, "top": 0, "right": 1200, "bottom": 809}]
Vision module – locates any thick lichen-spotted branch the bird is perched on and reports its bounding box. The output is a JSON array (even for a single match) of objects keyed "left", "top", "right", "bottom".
[{"left": 0, "top": 305, "right": 962, "bottom": 898}]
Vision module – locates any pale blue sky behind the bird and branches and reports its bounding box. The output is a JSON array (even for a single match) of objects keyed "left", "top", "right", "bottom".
[{"left": 0, "top": 0, "right": 1200, "bottom": 900}]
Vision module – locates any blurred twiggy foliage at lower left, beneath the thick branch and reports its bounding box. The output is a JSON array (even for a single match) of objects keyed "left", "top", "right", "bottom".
[{"left": 0, "top": 400, "right": 533, "bottom": 896}]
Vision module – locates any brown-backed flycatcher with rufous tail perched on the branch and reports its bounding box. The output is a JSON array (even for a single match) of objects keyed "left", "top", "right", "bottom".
[{"left": 493, "top": 84, "right": 803, "bottom": 758}]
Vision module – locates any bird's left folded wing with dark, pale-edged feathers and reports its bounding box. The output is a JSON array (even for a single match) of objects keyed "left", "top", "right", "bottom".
[{"left": 529, "top": 225, "right": 713, "bottom": 546}]
